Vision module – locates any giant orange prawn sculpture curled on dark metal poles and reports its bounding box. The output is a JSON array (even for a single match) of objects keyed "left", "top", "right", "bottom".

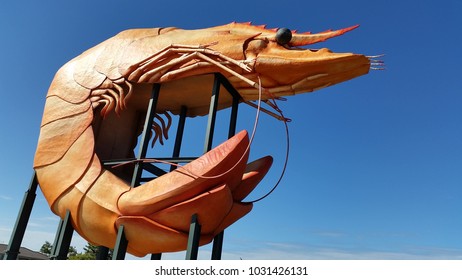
[{"left": 34, "top": 23, "right": 373, "bottom": 256}]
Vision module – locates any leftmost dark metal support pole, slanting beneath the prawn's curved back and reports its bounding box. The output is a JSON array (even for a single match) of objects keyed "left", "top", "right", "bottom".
[{"left": 3, "top": 172, "right": 38, "bottom": 260}]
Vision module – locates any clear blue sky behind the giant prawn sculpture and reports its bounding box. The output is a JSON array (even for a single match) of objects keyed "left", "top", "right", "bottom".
[{"left": 0, "top": 0, "right": 462, "bottom": 259}]
